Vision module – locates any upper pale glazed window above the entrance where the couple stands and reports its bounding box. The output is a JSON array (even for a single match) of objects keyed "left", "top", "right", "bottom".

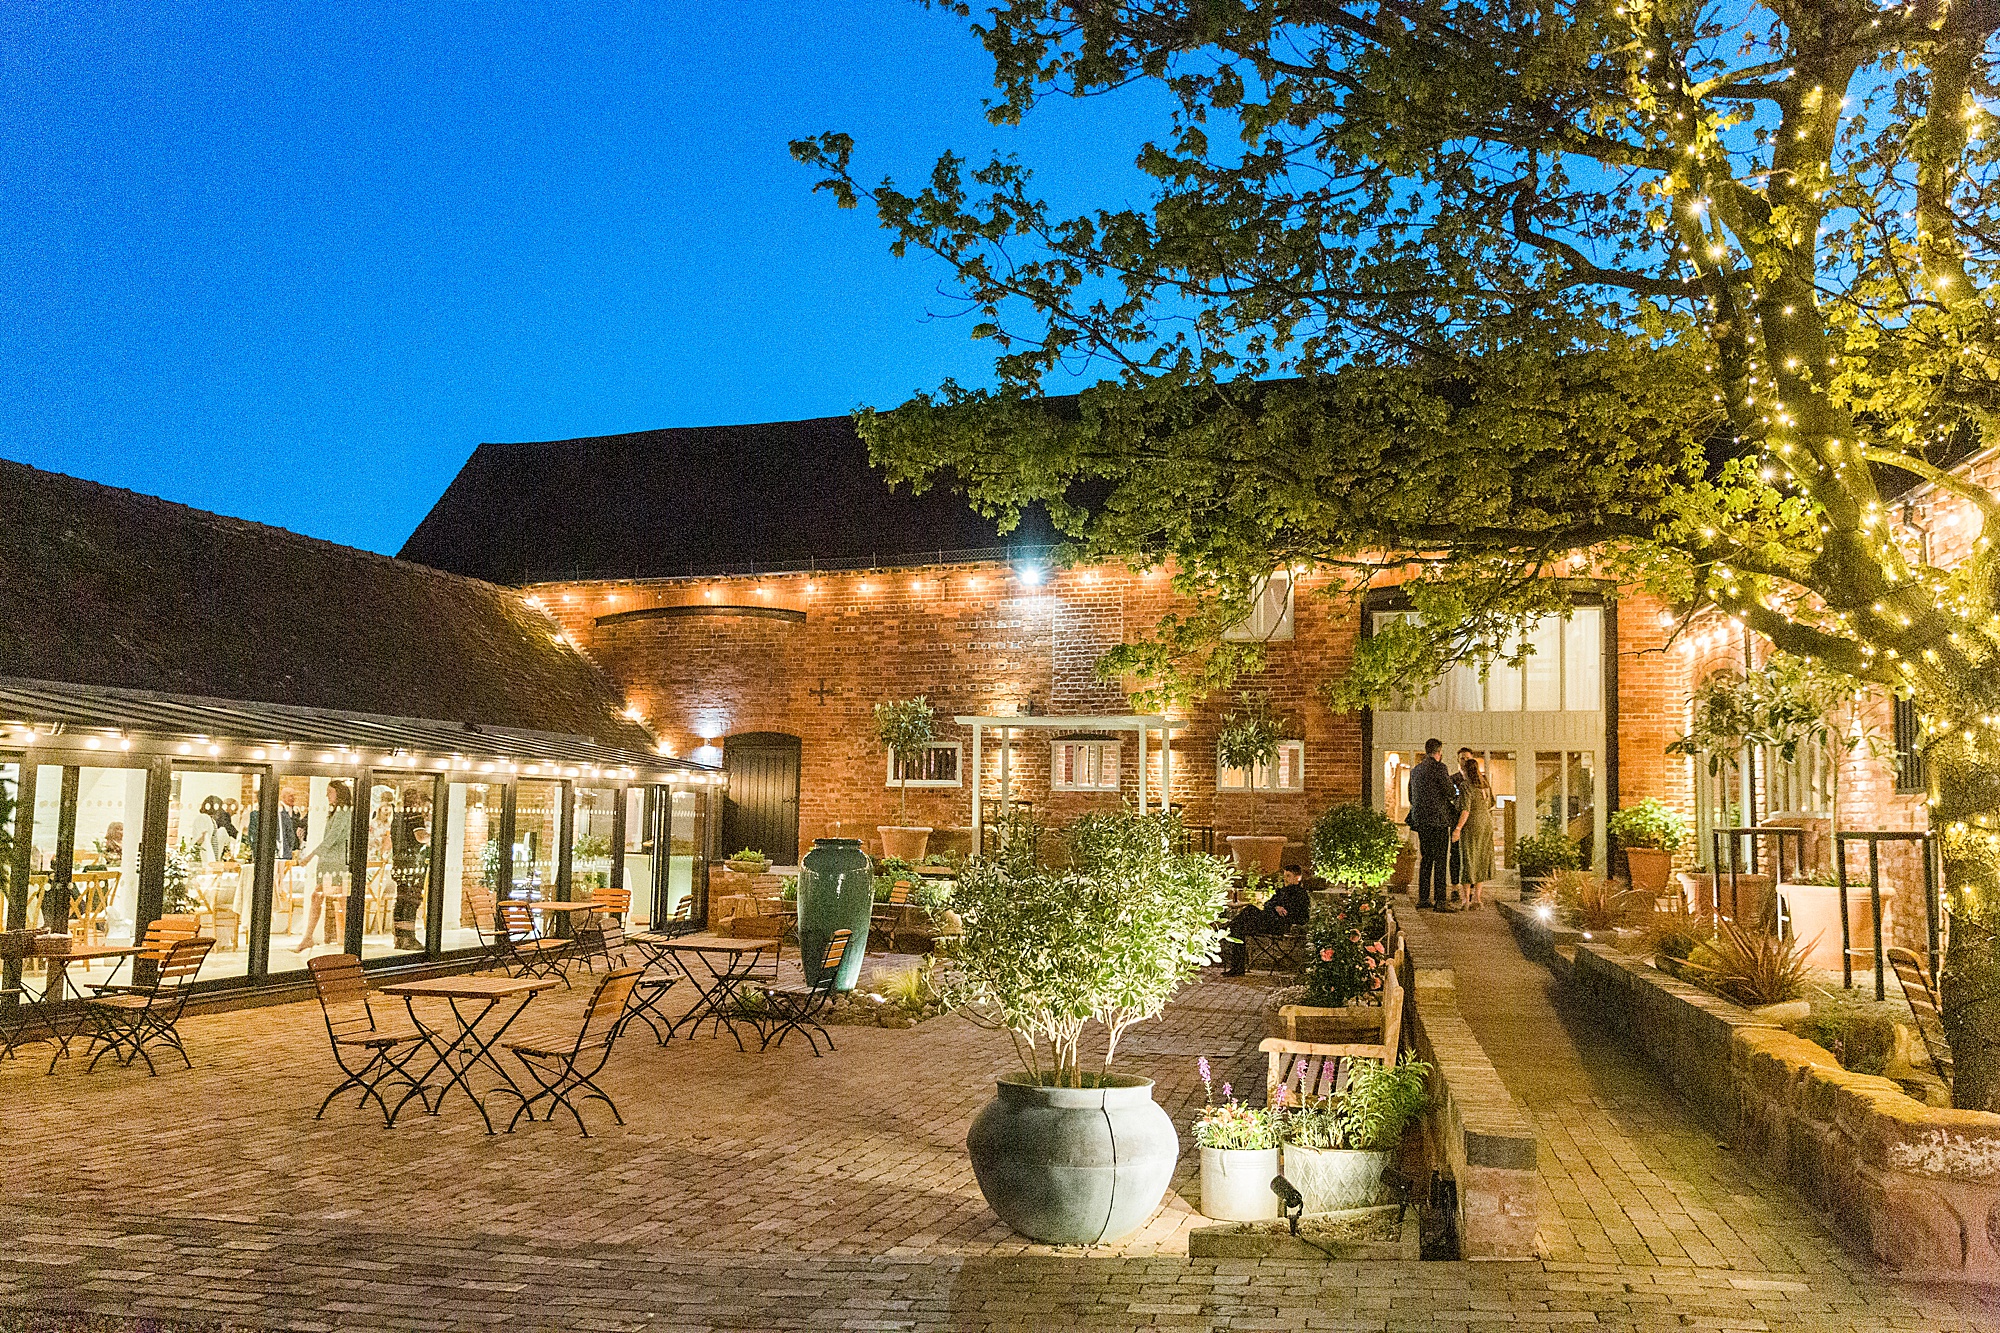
[{"left": 1374, "top": 606, "right": 1604, "bottom": 713}]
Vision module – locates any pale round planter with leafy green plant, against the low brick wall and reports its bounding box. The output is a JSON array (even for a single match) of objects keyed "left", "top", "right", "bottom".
[{"left": 1284, "top": 1057, "right": 1430, "bottom": 1213}]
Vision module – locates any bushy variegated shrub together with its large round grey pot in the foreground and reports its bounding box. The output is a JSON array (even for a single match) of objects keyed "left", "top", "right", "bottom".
[{"left": 926, "top": 811, "right": 1228, "bottom": 1245}]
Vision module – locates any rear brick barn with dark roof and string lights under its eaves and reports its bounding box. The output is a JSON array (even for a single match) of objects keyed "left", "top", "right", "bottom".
[{"left": 402, "top": 418, "right": 1720, "bottom": 880}]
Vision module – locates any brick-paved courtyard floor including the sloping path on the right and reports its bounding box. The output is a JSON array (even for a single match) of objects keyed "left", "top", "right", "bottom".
[{"left": 0, "top": 896, "right": 2000, "bottom": 1333}]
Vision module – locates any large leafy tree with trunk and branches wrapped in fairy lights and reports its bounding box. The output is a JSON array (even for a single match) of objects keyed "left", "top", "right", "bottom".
[{"left": 794, "top": 0, "right": 2000, "bottom": 1109}]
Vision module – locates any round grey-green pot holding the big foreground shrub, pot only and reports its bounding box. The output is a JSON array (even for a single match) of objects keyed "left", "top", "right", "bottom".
[{"left": 966, "top": 1075, "right": 1168, "bottom": 1245}]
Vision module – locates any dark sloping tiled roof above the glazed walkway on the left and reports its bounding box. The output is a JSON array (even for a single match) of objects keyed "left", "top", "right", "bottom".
[{"left": 0, "top": 460, "right": 650, "bottom": 749}]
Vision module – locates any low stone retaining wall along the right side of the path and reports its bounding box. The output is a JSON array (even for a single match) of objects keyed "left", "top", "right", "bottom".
[{"left": 1514, "top": 896, "right": 2000, "bottom": 1283}]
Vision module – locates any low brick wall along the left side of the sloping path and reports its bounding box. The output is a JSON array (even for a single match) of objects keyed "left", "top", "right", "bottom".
[{"left": 1404, "top": 913, "right": 1540, "bottom": 1259}]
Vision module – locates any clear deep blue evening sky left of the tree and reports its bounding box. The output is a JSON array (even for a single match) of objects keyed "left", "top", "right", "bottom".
[{"left": 0, "top": 0, "right": 1160, "bottom": 550}]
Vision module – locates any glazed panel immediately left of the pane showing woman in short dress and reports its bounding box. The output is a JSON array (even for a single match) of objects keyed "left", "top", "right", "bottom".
[{"left": 160, "top": 769, "right": 262, "bottom": 977}]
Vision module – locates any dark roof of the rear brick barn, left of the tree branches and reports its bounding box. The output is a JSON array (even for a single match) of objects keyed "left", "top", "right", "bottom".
[{"left": 400, "top": 416, "right": 1052, "bottom": 582}]
